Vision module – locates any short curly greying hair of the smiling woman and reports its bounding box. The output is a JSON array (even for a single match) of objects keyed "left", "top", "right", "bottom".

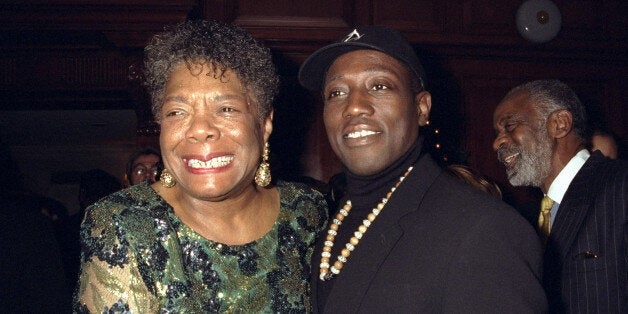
[{"left": 144, "top": 20, "right": 279, "bottom": 122}]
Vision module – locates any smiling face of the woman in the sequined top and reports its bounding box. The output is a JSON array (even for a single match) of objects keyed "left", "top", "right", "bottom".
[{"left": 160, "top": 63, "right": 272, "bottom": 201}]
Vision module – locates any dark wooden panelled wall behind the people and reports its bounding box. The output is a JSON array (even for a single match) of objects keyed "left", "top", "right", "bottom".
[{"left": 0, "top": 0, "right": 628, "bottom": 206}]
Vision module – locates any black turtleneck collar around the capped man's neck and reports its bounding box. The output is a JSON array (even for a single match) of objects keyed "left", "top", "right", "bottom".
[{"left": 343, "top": 136, "right": 423, "bottom": 211}]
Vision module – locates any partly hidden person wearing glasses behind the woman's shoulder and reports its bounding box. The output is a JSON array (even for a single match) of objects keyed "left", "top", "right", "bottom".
[{"left": 124, "top": 147, "right": 162, "bottom": 187}]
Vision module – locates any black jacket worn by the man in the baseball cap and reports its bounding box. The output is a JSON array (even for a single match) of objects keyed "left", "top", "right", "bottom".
[{"left": 312, "top": 155, "right": 547, "bottom": 313}]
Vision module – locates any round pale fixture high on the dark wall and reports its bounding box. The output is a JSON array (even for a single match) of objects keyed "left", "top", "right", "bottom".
[{"left": 516, "top": 0, "right": 562, "bottom": 43}]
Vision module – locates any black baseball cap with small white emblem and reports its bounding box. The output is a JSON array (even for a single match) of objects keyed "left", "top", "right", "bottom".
[{"left": 299, "top": 26, "right": 425, "bottom": 90}]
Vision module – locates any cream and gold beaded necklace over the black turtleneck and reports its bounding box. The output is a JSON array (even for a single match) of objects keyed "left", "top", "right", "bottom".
[{"left": 319, "top": 166, "right": 413, "bottom": 281}]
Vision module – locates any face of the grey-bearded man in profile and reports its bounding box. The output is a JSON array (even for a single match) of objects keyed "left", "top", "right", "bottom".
[{"left": 493, "top": 92, "right": 552, "bottom": 187}]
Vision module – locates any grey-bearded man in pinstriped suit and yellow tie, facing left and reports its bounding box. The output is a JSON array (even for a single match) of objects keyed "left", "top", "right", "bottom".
[{"left": 493, "top": 80, "right": 628, "bottom": 313}]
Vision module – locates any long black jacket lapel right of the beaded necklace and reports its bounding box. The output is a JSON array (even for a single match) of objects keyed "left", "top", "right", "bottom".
[{"left": 324, "top": 154, "right": 442, "bottom": 312}]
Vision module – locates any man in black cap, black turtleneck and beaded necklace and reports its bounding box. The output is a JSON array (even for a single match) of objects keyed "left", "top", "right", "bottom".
[{"left": 299, "top": 26, "right": 547, "bottom": 313}]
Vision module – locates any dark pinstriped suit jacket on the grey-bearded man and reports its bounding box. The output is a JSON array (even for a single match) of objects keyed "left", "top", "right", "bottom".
[{"left": 544, "top": 152, "right": 628, "bottom": 313}]
